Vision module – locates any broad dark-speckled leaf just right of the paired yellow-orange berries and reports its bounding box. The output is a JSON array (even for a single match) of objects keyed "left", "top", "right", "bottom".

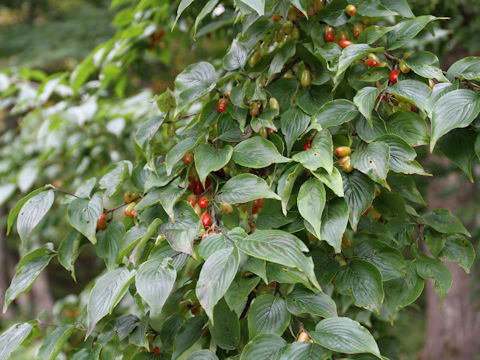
[{"left": 351, "top": 142, "right": 390, "bottom": 189}]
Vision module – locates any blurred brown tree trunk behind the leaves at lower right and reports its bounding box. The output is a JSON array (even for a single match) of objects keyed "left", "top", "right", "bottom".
[{"left": 420, "top": 159, "right": 480, "bottom": 360}]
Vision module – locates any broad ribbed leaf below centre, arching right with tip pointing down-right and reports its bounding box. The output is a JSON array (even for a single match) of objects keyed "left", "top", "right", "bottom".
[{"left": 238, "top": 230, "right": 319, "bottom": 287}]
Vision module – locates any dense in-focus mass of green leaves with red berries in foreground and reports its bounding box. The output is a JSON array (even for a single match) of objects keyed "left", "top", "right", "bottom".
[{"left": 0, "top": 0, "right": 480, "bottom": 360}]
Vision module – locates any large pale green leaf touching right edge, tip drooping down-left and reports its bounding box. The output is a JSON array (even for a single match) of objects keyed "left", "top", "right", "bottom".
[{"left": 430, "top": 89, "right": 480, "bottom": 151}]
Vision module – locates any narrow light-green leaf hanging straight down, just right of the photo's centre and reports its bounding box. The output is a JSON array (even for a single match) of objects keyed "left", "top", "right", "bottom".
[{"left": 297, "top": 177, "right": 326, "bottom": 239}]
